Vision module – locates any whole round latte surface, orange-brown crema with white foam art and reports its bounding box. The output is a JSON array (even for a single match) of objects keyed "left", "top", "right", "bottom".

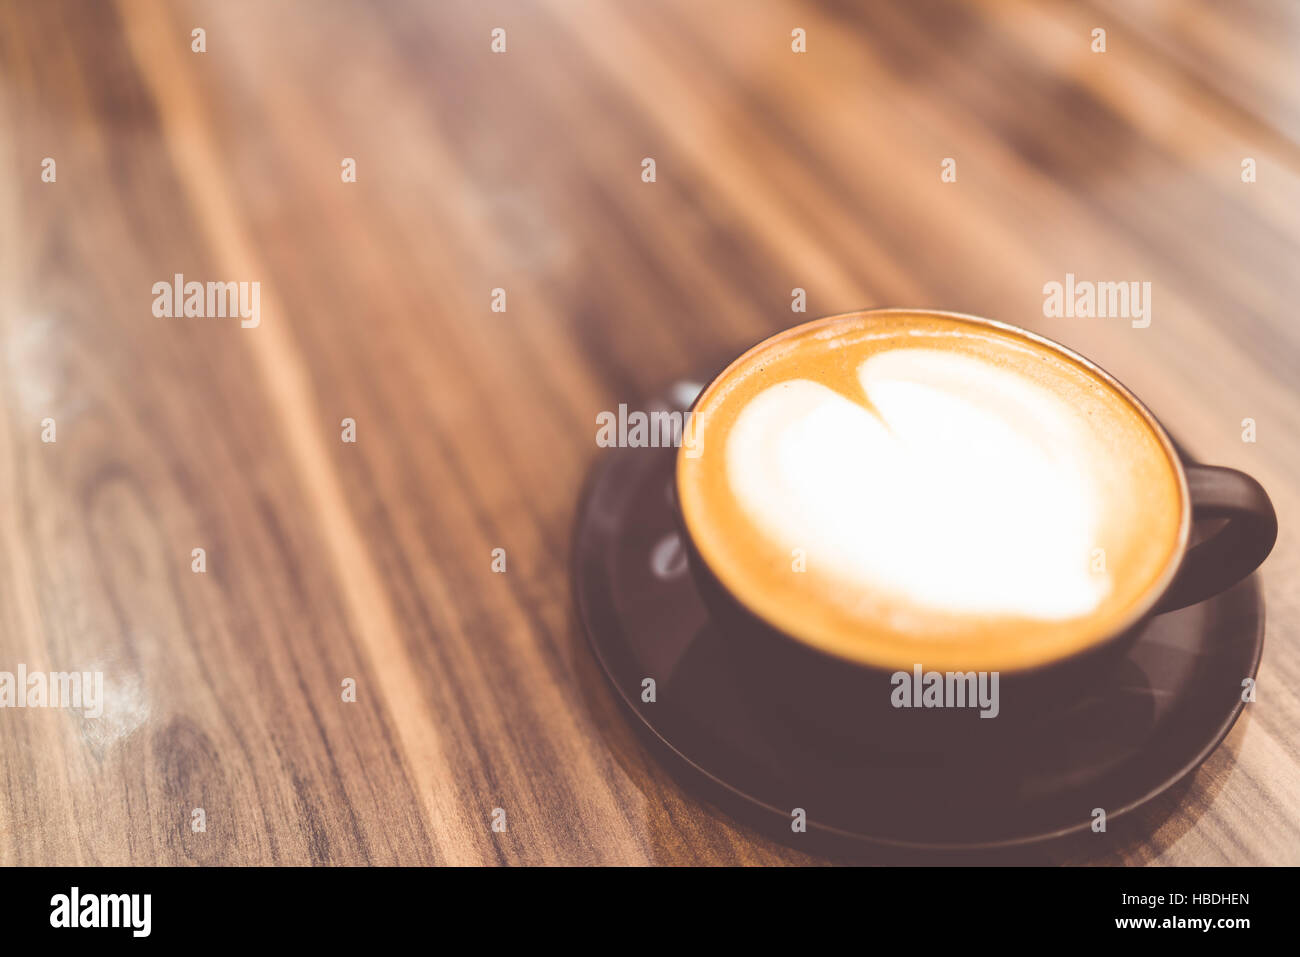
[{"left": 677, "top": 311, "right": 1188, "bottom": 671}]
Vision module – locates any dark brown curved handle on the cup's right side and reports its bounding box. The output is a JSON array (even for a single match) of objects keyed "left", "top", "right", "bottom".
[{"left": 1156, "top": 465, "right": 1278, "bottom": 614}]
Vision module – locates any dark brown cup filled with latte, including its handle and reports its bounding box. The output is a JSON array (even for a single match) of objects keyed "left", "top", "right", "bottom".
[{"left": 673, "top": 309, "right": 1277, "bottom": 745}]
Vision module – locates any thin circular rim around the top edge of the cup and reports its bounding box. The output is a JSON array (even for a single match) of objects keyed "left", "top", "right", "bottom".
[{"left": 672, "top": 306, "right": 1192, "bottom": 674}]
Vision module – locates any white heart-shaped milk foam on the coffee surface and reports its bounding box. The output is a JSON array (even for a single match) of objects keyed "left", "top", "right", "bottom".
[{"left": 725, "top": 347, "right": 1113, "bottom": 620}]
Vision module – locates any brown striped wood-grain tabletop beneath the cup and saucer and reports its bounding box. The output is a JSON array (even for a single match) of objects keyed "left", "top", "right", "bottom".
[{"left": 0, "top": 0, "right": 1300, "bottom": 863}]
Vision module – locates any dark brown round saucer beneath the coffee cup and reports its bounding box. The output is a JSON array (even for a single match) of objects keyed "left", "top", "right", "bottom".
[{"left": 573, "top": 382, "right": 1264, "bottom": 853}]
